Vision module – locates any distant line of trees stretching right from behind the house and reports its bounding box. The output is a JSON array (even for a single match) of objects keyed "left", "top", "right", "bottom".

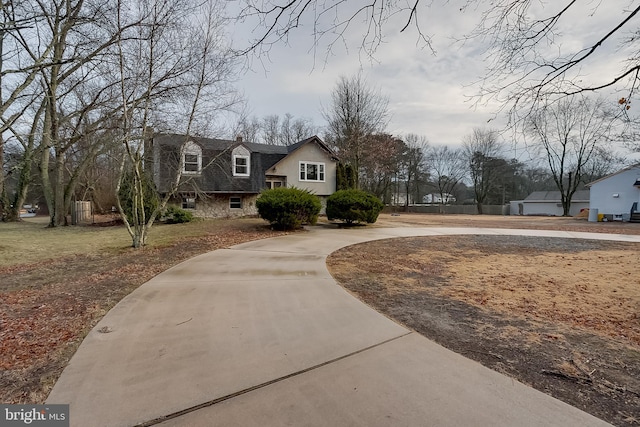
[{"left": 324, "top": 74, "right": 622, "bottom": 215}]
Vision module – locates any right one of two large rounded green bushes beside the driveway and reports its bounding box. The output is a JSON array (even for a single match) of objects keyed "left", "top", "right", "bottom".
[{"left": 327, "top": 190, "right": 384, "bottom": 224}]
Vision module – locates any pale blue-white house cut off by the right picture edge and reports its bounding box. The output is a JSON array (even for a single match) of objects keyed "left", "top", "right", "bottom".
[{"left": 587, "top": 163, "right": 640, "bottom": 220}]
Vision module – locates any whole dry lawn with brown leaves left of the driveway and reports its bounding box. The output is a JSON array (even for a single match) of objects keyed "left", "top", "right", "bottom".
[{"left": 0, "top": 219, "right": 283, "bottom": 403}]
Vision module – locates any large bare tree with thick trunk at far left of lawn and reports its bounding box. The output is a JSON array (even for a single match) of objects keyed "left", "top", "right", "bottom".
[{"left": 2, "top": 0, "right": 134, "bottom": 226}]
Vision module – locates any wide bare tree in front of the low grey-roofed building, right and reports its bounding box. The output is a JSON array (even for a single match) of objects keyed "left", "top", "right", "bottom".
[{"left": 527, "top": 96, "right": 614, "bottom": 216}]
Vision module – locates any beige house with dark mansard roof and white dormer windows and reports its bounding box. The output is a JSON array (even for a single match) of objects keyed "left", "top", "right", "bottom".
[{"left": 145, "top": 134, "right": 338, "bottom": 217}]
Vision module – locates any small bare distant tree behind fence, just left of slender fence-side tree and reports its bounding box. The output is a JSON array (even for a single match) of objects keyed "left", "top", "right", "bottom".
[{"left": 427, "top": 145, "right": 467, "bottom": 210}]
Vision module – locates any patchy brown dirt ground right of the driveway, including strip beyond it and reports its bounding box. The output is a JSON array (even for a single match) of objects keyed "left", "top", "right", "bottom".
[{"left": 328, "top": 214, "right": 640, "bottom": 425}]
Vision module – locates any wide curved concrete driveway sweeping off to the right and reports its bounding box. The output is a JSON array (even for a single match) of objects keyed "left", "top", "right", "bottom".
[{"left": 47, "top": 227, "right": 640, "bottom": 427}]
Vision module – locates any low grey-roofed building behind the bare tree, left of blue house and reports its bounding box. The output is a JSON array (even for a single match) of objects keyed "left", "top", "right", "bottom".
[{"left": 511, "top": 190, "right": 589, "bottom": 216}]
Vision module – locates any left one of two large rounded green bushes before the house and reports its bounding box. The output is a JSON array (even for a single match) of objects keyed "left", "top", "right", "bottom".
[{"left": 256, "top": 187, "right": 322, "bottom": 230}]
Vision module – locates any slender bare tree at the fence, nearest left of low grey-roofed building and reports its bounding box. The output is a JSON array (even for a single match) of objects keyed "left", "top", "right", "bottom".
[{"left": 463, "top": 128, "right": 504, "bottom": 214}]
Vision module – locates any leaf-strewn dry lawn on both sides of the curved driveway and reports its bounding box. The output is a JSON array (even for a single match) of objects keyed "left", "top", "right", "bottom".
[{"left": 0, "top": 214, "right": 640, "bottom": 425}]
